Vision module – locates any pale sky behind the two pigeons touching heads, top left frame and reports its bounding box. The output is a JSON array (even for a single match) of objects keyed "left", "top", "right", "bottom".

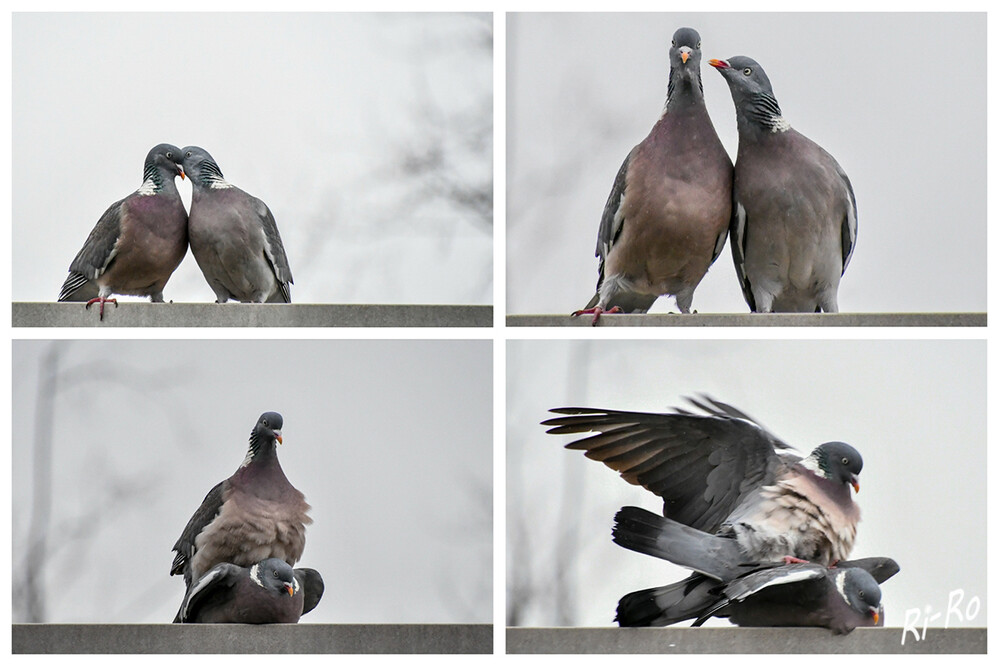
[{"left": 12, "top": 13, "right": 493, "bottom": 303}]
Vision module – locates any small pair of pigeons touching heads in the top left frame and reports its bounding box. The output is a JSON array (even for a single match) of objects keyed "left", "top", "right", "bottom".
[{"left": 59, "top": 143, "right": 292, "bottom": 320}]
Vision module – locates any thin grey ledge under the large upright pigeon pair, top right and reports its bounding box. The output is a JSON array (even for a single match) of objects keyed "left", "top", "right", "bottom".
[{"left": 506, "top": 312, "right": 987, "bottom": 327}]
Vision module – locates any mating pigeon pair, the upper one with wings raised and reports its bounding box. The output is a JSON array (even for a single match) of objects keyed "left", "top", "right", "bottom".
[{"left": 543, "top": 398, "right": 899, "bottom": 634}]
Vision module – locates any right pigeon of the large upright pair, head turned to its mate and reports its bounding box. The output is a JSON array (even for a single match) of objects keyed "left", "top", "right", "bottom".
[{"left": 708, "top": 56, "right": 857, "bottom": 312}]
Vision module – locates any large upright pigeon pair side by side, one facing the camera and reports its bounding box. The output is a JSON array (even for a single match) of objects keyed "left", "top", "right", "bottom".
[{"left": 574, "top": 28, "right": 857, "bottom": 325}]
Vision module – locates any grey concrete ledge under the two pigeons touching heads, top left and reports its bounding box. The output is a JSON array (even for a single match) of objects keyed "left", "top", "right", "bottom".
[{"left": 11, "top": 301, "right": 493, "bottom": 328}]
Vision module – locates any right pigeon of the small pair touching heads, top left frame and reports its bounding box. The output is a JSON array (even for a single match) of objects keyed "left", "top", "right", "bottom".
[{"left": 183, "top": 146, "right": 294, "bottom": 303}]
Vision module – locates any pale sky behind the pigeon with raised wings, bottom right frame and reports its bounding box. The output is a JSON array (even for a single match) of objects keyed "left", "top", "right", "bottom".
[{"left": 506, "top": 340, "right": 988, "bottom": 627}]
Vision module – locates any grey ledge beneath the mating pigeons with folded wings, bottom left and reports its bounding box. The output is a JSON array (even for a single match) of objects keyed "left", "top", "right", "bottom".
[{"left": 11, "top": 624, "right": 493, "bottom": 654}]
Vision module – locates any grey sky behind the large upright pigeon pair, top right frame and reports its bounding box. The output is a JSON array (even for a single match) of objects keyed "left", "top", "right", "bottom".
[{"left": 506, "top": 12, "right": 986, "bottom": 313}]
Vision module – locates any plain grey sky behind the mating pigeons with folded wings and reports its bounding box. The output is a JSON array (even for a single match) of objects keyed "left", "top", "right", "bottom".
[{"left": 12, "top": 340, "right": 493, "bottom": 623}]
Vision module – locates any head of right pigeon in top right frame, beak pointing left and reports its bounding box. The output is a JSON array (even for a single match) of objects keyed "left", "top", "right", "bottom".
[{"left": 708, "top": 56, "right": 791, "bottom": 136}]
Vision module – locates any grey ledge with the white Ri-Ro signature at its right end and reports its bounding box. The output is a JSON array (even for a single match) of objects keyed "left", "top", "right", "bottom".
[{"left": 506, "top": 627, "right": 988, "bottom": 654}]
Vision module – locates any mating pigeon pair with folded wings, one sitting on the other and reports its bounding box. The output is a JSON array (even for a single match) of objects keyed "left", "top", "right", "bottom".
[{"left": 170, "top": 412, "right": 324, "bottom": 624}]
